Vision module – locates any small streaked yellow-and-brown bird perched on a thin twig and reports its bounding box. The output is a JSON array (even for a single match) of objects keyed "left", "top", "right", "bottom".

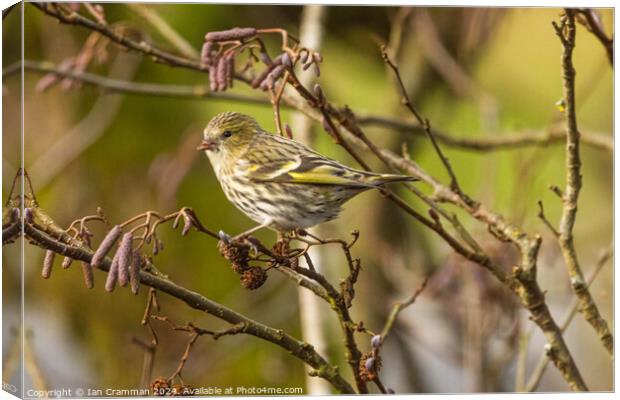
[{"left": 198, "top": 112, "right": 416, "bottom": 236}]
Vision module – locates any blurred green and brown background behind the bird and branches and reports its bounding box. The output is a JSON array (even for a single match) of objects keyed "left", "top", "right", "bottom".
[{"left": 2, "top": 3, "right": 613, "bottom": 393}]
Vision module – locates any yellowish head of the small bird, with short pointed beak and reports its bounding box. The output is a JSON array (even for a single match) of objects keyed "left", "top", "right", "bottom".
[{"left": 197, "top": 112, "right": 261, "bottom": 157}]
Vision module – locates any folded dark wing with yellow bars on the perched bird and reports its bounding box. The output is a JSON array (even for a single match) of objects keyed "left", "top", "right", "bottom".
[{"left": 238, "top": 154, "right": 374, "bottom": 187}]
